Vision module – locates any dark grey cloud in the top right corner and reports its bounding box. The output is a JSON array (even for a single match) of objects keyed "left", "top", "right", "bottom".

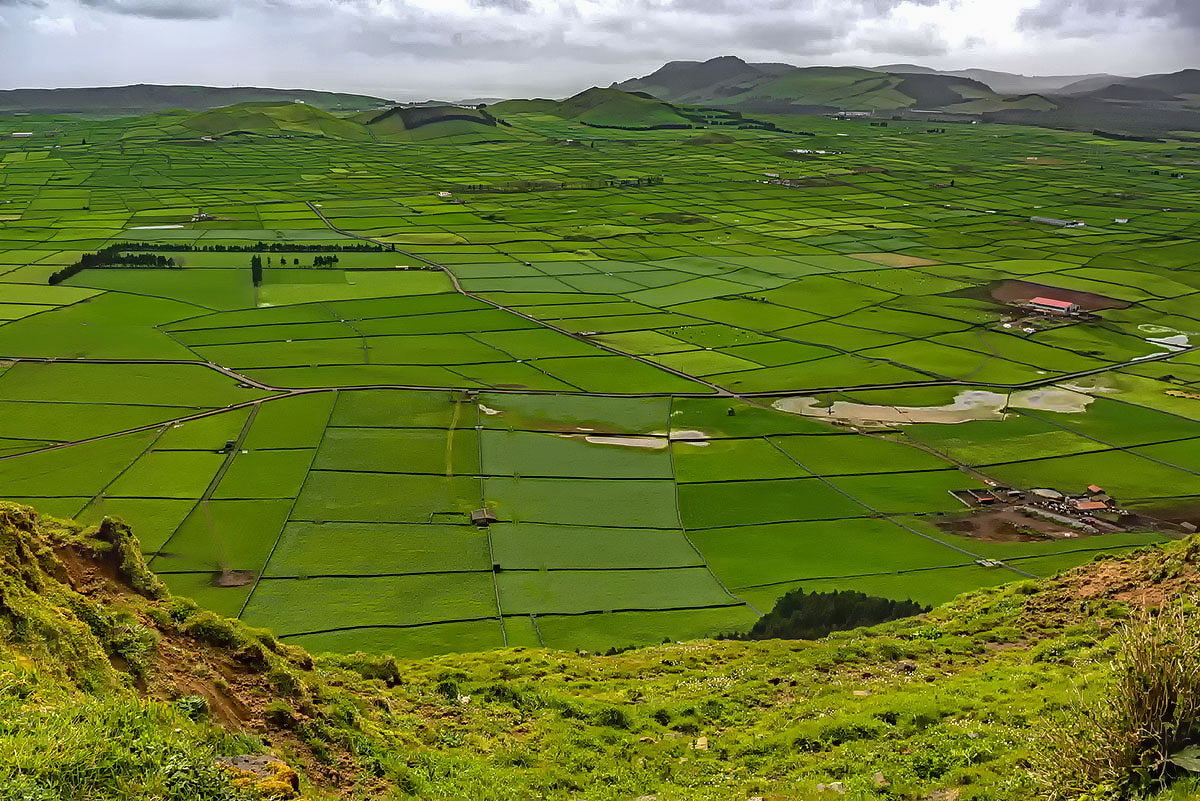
[{"left": 1018, "top": 0, "right": 1200, "bottom": 31}]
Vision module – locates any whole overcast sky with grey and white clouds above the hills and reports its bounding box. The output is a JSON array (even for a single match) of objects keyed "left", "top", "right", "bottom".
[{"left": 0, "top": 0, "right": 1200, "bottom": 100}]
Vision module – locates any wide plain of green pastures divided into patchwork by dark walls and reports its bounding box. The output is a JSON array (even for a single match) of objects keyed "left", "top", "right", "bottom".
[{"left": 0, "top": 110, "right": 1200, "bottom": 656}]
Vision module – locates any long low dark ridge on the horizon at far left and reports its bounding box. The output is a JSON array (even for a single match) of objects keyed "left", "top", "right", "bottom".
[{"left": 0, "top": 84, "right": 389, "bottom": 114}]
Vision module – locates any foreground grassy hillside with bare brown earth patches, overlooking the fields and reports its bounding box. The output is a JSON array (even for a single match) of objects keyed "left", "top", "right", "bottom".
[{"left": 7, "top": 504, "right": 1200, "bottom": 801}]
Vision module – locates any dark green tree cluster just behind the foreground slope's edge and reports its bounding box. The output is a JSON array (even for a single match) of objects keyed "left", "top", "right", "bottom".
[{"left": 727, "top": 590, "right": 930, "bottom": 639}]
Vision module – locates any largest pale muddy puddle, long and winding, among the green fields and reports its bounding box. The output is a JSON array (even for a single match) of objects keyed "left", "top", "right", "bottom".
[{"left": 772, "top": 387, "right": 1094, "bottom": 426}]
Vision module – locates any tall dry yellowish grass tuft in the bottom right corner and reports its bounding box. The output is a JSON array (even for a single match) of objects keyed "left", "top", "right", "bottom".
[{"left": 1037, "top": 606, "right": 1200, "bottom": 801}]
